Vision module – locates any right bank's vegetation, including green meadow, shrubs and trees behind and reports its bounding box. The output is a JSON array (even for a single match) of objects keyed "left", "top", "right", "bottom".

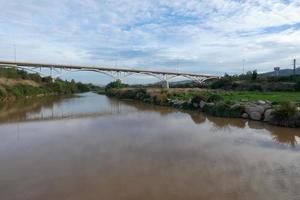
[{"left": 102, "top": 70, "right": 300, "bottom": 127}]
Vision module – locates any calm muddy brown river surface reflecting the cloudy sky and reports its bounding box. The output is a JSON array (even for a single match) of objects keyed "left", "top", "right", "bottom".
[{"left": 0, "top": 93, "right": 300, "bottom": 200}]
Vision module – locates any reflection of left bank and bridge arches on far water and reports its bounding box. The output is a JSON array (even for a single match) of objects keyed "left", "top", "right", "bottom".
[{"left": 0, "top": 93, "right": 136, "bottom": 123}]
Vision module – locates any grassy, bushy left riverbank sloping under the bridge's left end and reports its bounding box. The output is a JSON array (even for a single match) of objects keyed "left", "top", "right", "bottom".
[{"left": 0, "top": 68, "right": 100, "bottom": 100}]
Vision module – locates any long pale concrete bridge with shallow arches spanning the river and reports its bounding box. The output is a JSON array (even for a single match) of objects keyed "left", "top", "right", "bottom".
[{"left": 0, "top": 61, "right": 218, "bottom": 88}]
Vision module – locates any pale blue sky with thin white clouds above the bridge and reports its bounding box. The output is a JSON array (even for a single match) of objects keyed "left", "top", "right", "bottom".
[{"left": 0, "top": 0, "right": 300, "bottom": 83}]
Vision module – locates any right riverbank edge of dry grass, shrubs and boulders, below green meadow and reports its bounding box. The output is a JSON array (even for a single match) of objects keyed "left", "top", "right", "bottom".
[{"left": 106, "top": 88, "right": 300, "bottom": 128}]
